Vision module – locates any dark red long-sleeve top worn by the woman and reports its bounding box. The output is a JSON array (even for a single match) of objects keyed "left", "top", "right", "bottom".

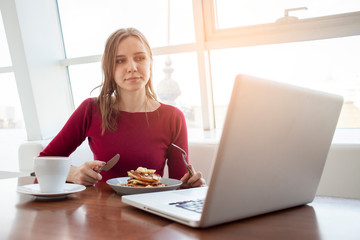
[{"left": 40, "top": 98, "right": 188, "bottom": 181}]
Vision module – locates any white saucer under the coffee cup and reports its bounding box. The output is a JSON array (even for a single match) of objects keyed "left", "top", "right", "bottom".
[{"left": 17, "top": 183, "right": 86, "bottom": 198}]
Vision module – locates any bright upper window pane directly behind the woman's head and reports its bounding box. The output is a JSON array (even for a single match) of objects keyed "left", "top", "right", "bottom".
[{"left": 58, "top": 0, "right": 195, "bottom": 58}]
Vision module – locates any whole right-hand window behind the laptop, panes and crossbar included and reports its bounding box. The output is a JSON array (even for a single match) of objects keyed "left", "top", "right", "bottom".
[{"left": 205, "top": 0, "right": 360, "bottom": 128}]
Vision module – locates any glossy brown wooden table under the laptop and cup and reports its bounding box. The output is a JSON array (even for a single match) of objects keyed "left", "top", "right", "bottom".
[{"left": 0, "top": 177, "right": 360, "bottom": 240}]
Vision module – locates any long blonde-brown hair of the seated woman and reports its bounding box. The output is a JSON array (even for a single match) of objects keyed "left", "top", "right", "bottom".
[{"left": 97, "top": 28, "right": 157, "bottom": 134}]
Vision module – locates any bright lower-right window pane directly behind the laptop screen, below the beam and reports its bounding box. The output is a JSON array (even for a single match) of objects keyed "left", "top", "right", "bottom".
[{"left": 211, "top": 36, "right": 360, "bottom": 128}]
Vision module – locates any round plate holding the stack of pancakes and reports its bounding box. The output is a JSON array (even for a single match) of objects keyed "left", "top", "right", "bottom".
[{"left": 106, "top": 177, "right": 182, "bottom": 195}]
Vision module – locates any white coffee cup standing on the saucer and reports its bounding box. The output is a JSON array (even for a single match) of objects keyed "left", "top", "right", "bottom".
[{"left": 34, "top": 157, "right": 70, "bottom": 193}]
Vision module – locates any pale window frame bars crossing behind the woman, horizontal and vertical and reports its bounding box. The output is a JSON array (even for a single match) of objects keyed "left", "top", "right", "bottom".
[{"left": 60, "top": 0, "right": 360, "bottom": 133}]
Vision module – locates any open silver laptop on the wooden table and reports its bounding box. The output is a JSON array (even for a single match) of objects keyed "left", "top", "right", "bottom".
[{"left": 122, "top": 75, "right": 343, "bottom": 227}]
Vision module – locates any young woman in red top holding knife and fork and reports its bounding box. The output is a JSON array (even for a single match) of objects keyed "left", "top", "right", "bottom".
[{"left": 40, "top": 28, "right": 205, "bottom": 188}]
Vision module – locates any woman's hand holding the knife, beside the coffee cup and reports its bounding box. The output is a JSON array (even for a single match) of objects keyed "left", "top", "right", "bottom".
[{"left": 67, "top": 160, "right": 105, "bottom": 186}]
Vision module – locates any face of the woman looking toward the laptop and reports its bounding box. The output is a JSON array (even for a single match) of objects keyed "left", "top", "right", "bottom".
[{"left": 114, "top": 36, "right": 151, "bottom": 93}]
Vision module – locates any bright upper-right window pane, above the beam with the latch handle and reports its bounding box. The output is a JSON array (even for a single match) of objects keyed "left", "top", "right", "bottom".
[{"left": 215, "top": 0, "right": 360, "bottom": 29}]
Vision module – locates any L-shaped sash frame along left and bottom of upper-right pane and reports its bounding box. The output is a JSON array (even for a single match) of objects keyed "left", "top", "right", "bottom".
[{"left": 203, "top": 0, "right": 360, "bottom": 49}]
